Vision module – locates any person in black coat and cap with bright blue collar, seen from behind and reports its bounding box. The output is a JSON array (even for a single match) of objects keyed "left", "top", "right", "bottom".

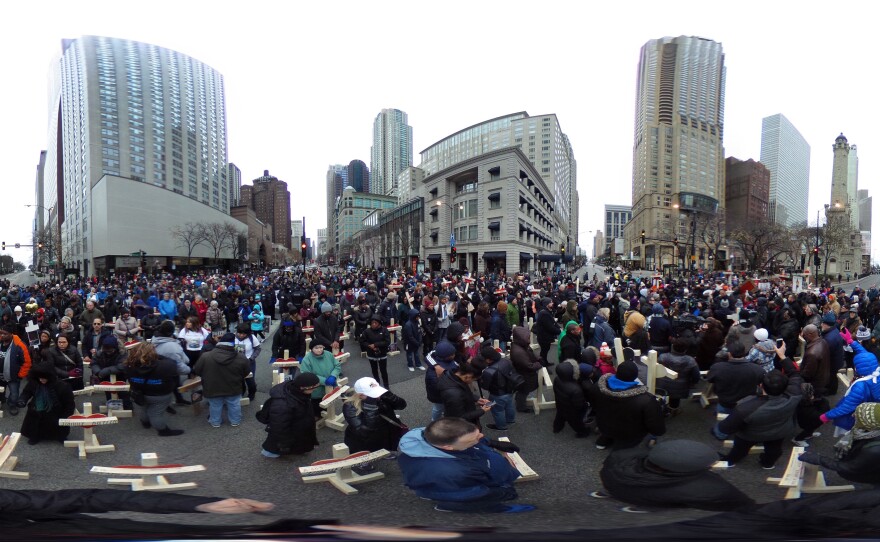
[{"left": 584, "top": 361, "right": 666, "bottom": 450}]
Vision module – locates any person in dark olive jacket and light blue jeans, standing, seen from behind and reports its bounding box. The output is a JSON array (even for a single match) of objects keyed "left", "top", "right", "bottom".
[{"left": 193, "top": 333, "right": 251, "bottom": 428}]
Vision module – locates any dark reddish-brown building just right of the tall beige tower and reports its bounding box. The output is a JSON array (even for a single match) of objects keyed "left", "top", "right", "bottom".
[{"left": 724, "top": 156, "right": 770, "bottom": 231}]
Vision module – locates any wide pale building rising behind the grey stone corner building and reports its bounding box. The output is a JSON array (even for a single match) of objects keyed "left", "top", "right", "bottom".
[{"left": 418, "top": 111, "right": 578, "bottom": 254}]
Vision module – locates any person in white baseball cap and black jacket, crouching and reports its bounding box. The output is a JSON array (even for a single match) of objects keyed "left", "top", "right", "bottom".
[{"left": 342, "top": 377, "right": 409, "bottom": 474}]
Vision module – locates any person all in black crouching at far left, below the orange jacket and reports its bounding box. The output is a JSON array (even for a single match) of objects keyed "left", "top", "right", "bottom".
[{"left": 18, "top": 366, "right": 76, "bottom": 445}]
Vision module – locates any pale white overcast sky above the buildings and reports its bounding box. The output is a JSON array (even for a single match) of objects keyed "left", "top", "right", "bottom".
[{"left": 0, "top": 0, "right": 880, "bottom": 263}]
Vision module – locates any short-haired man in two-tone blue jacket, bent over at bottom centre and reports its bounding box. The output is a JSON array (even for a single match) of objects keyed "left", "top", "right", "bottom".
[{"left": 397, "top": 418, "right": 535, "bottom": 513}]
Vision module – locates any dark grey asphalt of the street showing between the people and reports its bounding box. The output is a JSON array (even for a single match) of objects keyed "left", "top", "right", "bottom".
[{"left": 0, "top": 323, "right": 868, "bottom": 532}]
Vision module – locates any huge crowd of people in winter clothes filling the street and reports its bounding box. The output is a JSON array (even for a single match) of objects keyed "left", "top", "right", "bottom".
[{"left": 0, "top": 270, "right": 880, "bottom": 512}]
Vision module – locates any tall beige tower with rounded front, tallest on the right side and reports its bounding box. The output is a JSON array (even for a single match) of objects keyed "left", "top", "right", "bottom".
[{"left": 628, "top": 36, "right": 725, "bottom": 269}]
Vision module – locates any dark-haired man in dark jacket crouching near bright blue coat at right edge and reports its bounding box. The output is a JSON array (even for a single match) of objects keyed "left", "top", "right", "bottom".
[{"left": 718, "top": 344, "right": 803, "bottom": 469}]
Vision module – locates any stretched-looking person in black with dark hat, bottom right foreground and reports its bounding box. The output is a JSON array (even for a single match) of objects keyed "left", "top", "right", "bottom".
[{"left": 593, "top": 440, "right": 755, "bottom": 511}]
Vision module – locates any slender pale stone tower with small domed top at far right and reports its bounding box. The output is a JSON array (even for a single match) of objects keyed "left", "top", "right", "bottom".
[{"left": 820, "top": 134, "right": 862, "bottom": 280}]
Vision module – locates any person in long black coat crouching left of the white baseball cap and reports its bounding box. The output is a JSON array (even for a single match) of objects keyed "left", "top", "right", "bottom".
[{"left": 261, "top": 372, "right": 323, "bottom": 458}]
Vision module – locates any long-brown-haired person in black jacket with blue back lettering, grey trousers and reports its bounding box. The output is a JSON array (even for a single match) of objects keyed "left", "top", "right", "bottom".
[{"left": 125, "top": 342, "right": 189, "bottom": 437}]
